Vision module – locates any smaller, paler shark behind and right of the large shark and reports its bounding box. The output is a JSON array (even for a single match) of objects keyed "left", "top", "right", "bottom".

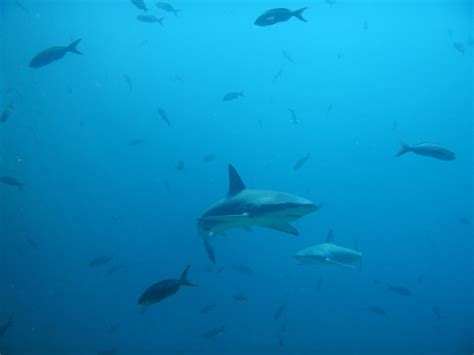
[{"left": 294, "top": 230, "right": 362, "bottom": 271}]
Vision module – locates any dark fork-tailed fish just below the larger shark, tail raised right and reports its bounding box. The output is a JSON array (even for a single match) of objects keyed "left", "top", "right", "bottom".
[{"left": 138, "top": 265, "right": 197, "bottom": 306}]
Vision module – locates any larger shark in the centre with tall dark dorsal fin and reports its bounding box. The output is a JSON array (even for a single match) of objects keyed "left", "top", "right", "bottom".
[{"left": 197, "top": 164, "right": 319, "bottom": 263}]
